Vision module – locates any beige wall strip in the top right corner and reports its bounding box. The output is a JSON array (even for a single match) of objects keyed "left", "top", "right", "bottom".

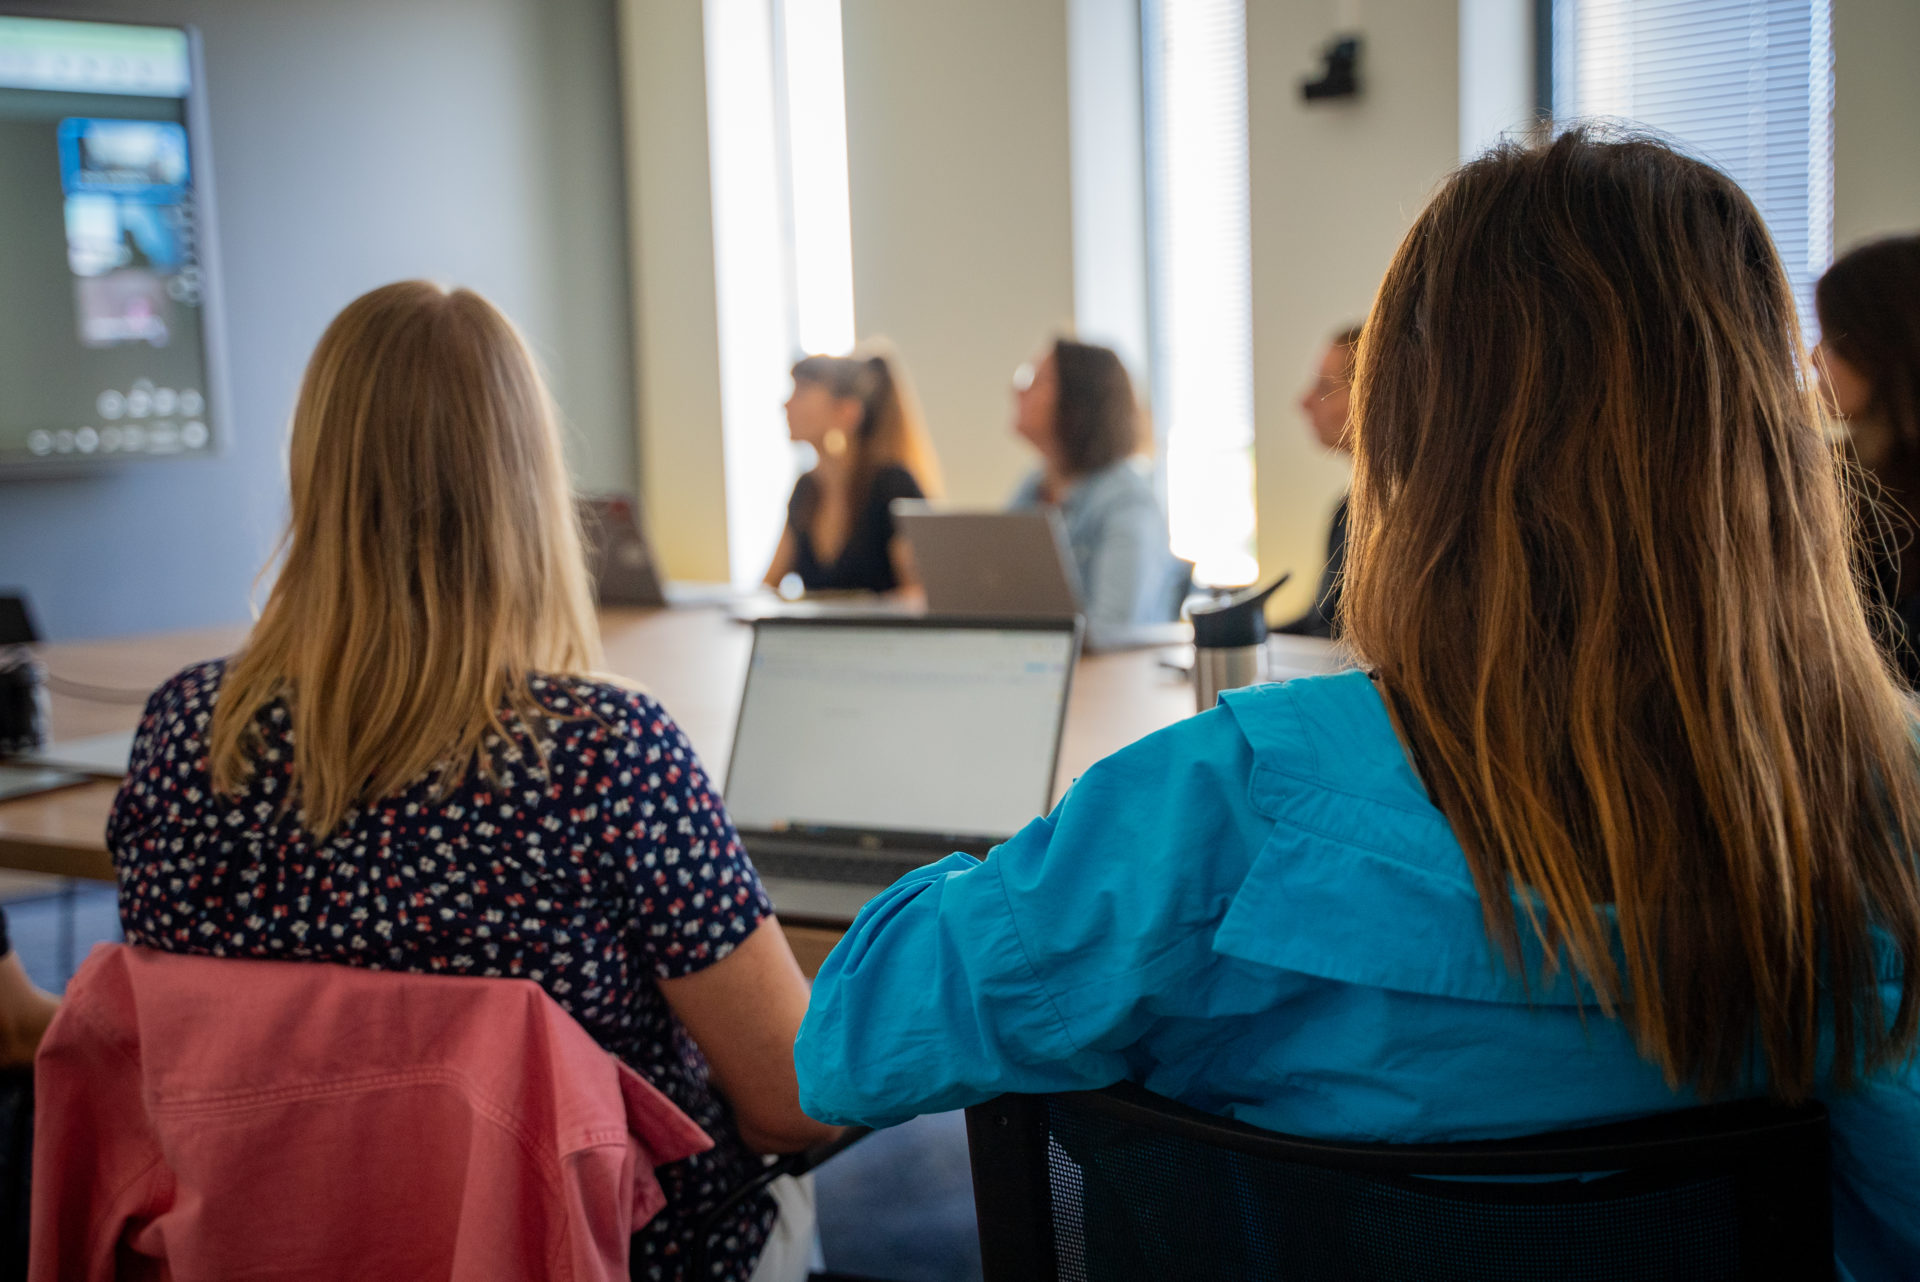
[{"left": 1834, "top": 0, "right": 1920, "bottom": 253}]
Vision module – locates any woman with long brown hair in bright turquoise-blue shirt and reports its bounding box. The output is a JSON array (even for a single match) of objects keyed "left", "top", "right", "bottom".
[{"left": 795, "top": 132, "right": 1920, "bottom": 1282}]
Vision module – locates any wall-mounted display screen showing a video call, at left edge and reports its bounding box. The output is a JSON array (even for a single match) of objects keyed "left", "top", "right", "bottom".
[{"left": 0, "top": 17, "right": 217, "bottom": 468}]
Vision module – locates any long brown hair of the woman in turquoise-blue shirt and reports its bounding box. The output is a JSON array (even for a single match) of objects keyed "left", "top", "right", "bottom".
[{"left": 1342, "top": 131, "right": 1920, "bottom": 1098}]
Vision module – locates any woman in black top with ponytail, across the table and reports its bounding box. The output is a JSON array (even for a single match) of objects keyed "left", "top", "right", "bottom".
[{"left": 766, "top": 351, "right": 939, "bottom": 593}]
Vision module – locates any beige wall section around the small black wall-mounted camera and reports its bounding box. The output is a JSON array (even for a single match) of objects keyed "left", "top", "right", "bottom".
[{"left": 1246, "top": 0, "right": 1459, "bottom": 616}]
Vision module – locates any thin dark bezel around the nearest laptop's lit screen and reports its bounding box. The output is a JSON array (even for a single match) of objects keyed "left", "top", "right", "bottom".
[{"left": 720, "top": 610, "right": 1085, "bottom": 850}]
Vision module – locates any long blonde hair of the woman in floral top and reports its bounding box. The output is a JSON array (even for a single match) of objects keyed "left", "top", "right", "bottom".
[{"left": 209, "top": 280, "right": 599, "bottom": 837}]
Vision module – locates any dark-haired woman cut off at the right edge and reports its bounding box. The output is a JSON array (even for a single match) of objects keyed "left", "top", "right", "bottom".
[{"left": 1814, "top": 236, "right": 1920, "bottom": 685}]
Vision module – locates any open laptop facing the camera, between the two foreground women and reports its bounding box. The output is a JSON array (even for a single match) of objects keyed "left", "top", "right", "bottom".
[{"left": 726, "top": 616, "right": 1079, "bottom": 925}]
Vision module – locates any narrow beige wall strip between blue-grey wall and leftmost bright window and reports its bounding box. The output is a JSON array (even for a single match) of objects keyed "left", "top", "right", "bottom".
[{"left": 620, "top": 0, "right": 728, "bottom": 582}]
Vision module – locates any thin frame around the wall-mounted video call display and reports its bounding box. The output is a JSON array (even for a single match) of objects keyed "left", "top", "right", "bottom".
[{"left": 0, "top": 2, "right": 232, "bottom": 480}]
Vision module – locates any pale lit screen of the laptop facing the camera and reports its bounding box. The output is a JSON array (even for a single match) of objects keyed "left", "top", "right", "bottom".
[{"left": 726, "top": 624, "right": 1073, "bottom": 837}]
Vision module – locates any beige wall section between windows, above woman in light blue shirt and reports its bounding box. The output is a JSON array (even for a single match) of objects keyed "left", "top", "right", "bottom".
[{"left": 841, "top": 0, "right": 1073, "bottom": 505}]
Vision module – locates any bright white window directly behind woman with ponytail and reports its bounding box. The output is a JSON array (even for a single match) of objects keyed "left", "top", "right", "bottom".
[{"left": 705, "top": 0, "right": 854, "bottom": 585}]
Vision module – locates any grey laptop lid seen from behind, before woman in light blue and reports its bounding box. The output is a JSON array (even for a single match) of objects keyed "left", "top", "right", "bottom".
[{"left": 893, "top": 501, "right": 1081, "bottom": 618}]
